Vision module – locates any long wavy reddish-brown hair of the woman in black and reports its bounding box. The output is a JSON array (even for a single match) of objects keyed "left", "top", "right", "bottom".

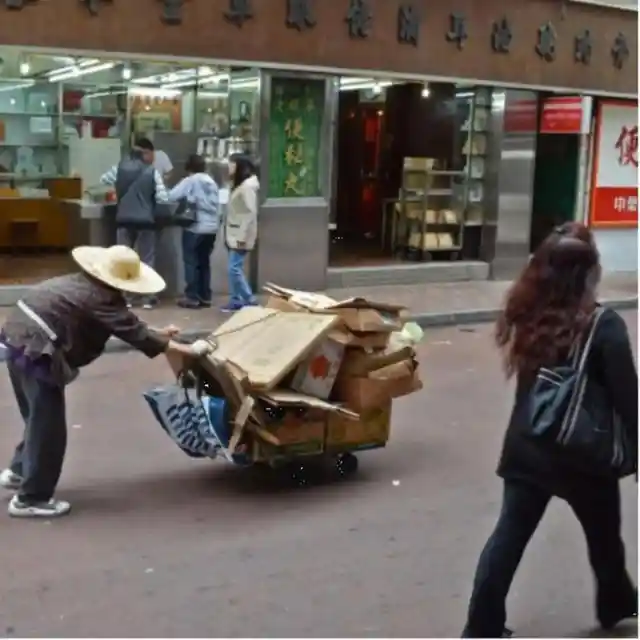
[{"left": 495, "top": 222, "right": 600, "bottom": 377}]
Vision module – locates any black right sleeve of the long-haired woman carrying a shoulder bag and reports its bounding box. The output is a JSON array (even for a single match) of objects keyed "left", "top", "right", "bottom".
[{"left": 599, "top": 311, "right": 638, "bottom": 450}]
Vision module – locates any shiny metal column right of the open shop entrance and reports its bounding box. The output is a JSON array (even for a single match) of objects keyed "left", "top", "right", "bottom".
[{"left": 481, "top": 89, "right": 537, "bottom": 280}]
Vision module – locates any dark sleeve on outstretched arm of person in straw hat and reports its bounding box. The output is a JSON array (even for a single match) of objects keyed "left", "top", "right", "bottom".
[{"left": 92, "top": 301, "right": 169, "bottom": 358}]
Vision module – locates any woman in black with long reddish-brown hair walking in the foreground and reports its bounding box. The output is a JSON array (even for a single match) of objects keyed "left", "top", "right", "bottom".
[{"left": 463, "top": 223, "right": 638, "bottom": 638}]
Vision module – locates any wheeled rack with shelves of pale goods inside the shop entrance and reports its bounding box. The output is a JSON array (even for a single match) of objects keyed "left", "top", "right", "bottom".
[{"left": 392, "top": 158, "right": 466, "bottom": 261}]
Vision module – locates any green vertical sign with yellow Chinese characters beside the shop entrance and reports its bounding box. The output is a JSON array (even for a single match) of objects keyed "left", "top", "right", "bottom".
[{"left": 268, "top": 78, "right": 325, "bottom": 198}]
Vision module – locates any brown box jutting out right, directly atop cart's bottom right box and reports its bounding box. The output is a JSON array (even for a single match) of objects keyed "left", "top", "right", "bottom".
[{"left": 333, "top": 360, "right": 422, "bottom": 413}]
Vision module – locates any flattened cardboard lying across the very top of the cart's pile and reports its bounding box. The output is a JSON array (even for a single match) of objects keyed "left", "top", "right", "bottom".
[{"left": 265, "top": 283, "right": 406, "bottom": 333}]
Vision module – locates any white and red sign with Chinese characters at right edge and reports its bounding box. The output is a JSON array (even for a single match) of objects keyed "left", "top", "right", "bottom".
[{"left": 590, "top": 100, "right": 638, "bottom": 227}]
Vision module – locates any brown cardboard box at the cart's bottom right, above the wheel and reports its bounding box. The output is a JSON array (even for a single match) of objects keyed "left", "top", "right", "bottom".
[{"left": 326, "top": 401, "right": 391, "bottom": 451}]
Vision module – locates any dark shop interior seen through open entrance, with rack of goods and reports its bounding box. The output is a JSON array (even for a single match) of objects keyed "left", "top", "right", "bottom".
[{"left": 329, "top": 78, "right": 491, "bottom": 267}]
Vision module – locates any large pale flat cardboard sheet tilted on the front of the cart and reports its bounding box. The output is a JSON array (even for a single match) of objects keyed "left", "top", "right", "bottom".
[{"left": 207, "top": 307, "right": 340, "bottom": 390}]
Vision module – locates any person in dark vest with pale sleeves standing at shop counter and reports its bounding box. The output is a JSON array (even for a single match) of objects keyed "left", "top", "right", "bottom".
[{"left": 100, "top": 138, "right": 169, "bottom": 309}]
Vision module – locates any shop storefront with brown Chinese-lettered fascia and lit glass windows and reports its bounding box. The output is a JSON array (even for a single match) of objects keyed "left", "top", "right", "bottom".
[{"left": 0, "top": 0, "right": 637, "bottom": 296}]
